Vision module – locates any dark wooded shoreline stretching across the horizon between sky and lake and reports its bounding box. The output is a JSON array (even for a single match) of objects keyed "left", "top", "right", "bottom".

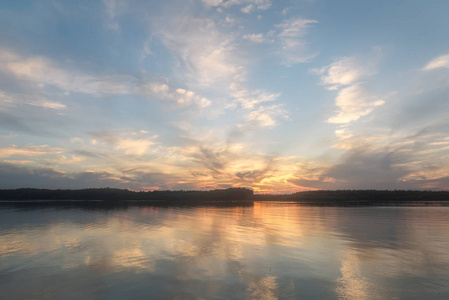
[{"left": 0, "top": 188, "right": 449, "bottom": 206}]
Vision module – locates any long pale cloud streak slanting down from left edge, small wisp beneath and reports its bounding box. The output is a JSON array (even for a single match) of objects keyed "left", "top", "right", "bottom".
[{"left": 0, "top": 49, "right": 210, "bottom": 109}]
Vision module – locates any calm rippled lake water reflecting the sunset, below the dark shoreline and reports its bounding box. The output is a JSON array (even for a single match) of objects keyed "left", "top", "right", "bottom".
[{"left": 0, "top": 203, "right": 449, "bottom": 300}]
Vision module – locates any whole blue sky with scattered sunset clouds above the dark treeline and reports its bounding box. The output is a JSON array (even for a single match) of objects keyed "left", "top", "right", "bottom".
[{"left": 0, "top": 0, "right": 449, "bottom": 193}]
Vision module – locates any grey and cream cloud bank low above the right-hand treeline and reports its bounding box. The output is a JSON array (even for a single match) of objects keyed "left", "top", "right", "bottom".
[{"left": 300, "top": 122, "right": 449, "bottom": 189}]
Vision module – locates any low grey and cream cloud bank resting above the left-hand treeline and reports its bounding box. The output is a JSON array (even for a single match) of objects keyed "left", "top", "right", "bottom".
[{"left": 0, "top": 138, "right": 201, "bottom": 189}]
